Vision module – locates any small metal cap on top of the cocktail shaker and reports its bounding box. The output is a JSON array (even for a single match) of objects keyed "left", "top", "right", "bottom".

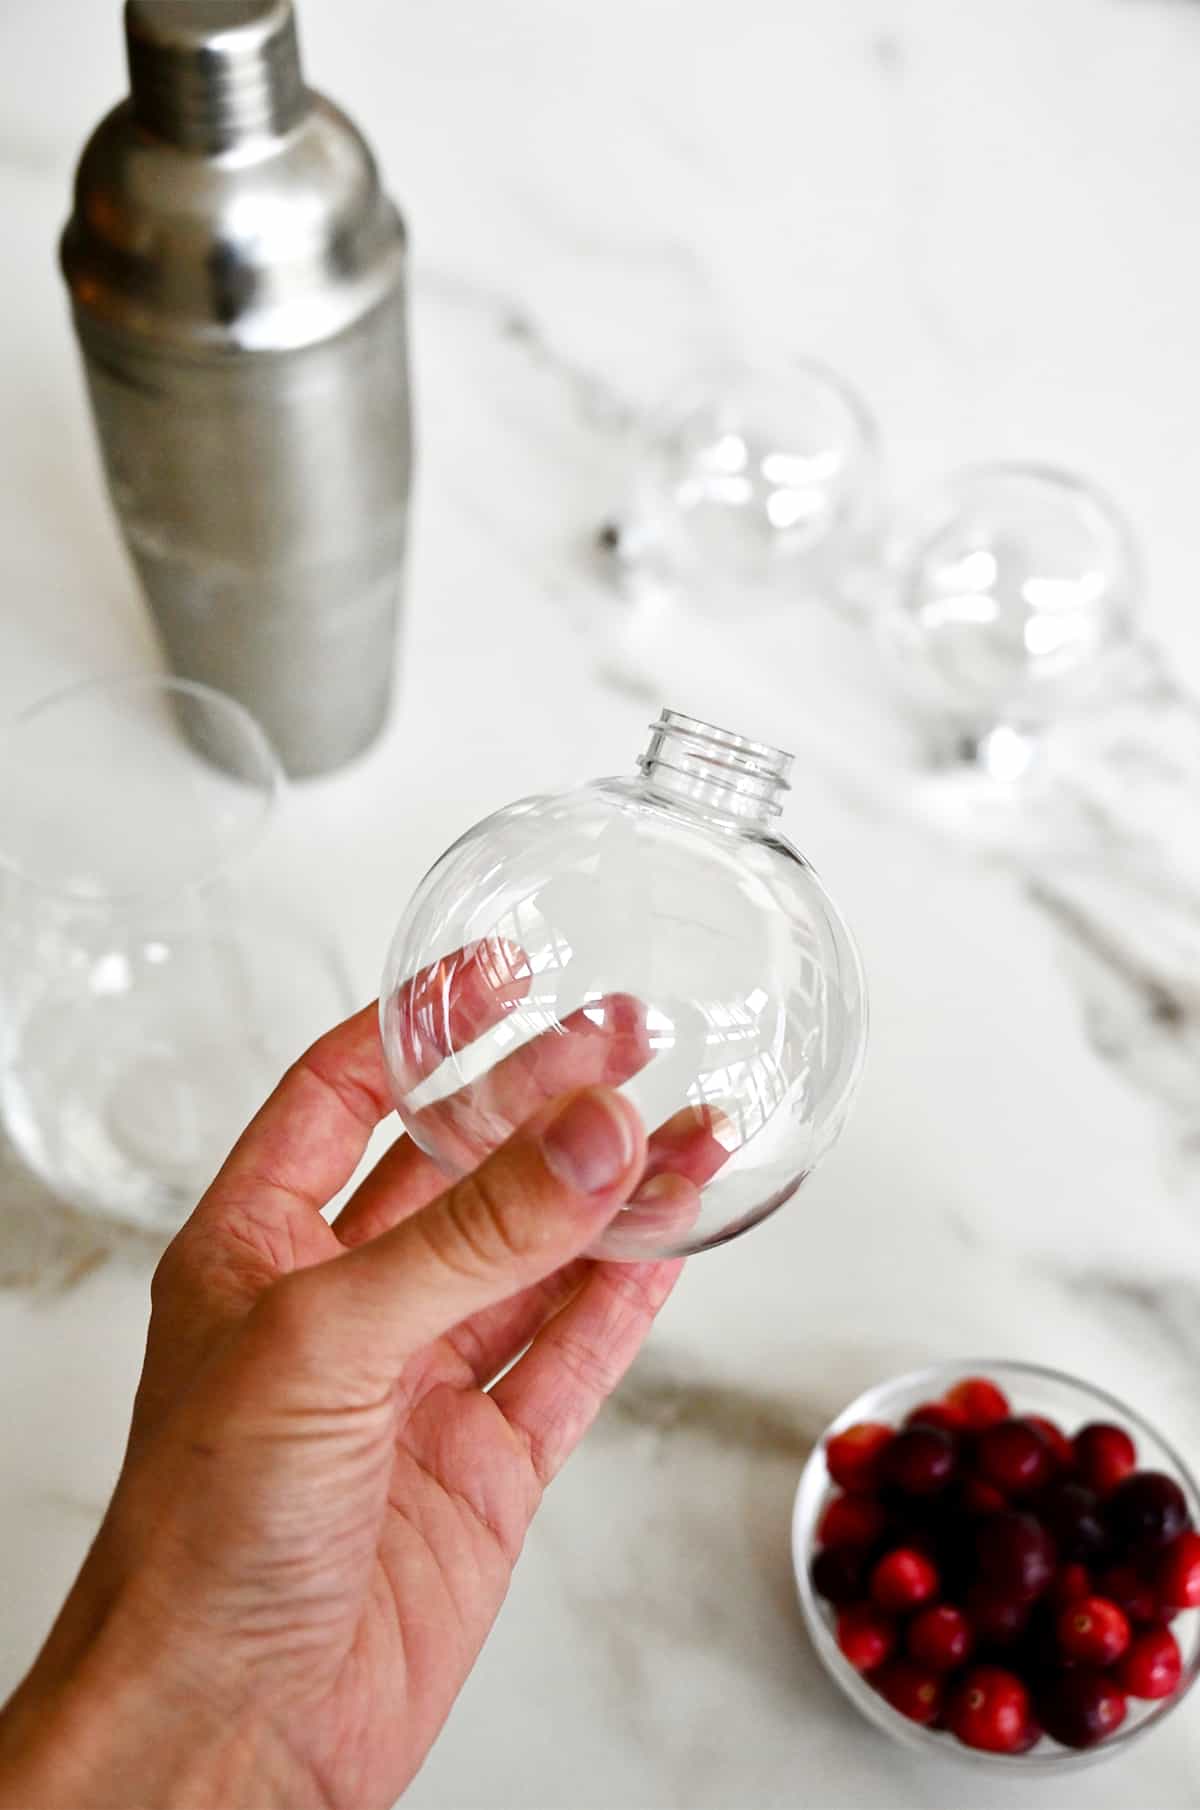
[{"left": 125, "top": 0, "right": 306, "bottom": 152}]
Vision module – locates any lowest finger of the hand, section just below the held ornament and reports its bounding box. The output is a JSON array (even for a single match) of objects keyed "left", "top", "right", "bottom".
[{"left": 490, "top": 1258, "right": 682, "bottom": 1486}]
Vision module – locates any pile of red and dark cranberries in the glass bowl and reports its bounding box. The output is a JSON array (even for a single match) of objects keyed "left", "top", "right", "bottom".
[{"left": 811, "top": 1377, "right": 1200, "bottom": 1754}]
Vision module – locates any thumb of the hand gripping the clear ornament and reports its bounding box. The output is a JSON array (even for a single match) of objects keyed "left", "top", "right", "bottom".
[{"left": 295, "top": 1088, "right": 646, "bottom": 1379}]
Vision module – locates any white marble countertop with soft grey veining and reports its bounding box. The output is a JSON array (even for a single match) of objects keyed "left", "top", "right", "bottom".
[{"left": 0, "top": 0, "right": 1200, "bottom": 1810}]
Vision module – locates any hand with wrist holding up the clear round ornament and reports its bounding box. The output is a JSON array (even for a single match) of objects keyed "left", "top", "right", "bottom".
[{"left": 0, "top": 956, "right": 705, "bottom": 1810}]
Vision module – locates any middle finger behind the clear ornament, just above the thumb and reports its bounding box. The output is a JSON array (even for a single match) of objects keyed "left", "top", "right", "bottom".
[{"left": 333, "top": 994, "right": 658, "bottom": 1245}]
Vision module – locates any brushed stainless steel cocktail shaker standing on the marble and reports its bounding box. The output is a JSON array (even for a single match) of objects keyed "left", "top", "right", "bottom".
[{"left": 62, "top": 0, "right": 411, "bottom": 773}]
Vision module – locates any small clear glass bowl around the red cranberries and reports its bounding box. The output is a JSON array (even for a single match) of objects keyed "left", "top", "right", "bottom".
[{"left": 791, "top": 1358, "right": 1200, "bottom": 1777}]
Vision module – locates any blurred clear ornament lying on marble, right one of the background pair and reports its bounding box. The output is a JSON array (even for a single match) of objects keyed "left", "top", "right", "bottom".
[{"left": 880, "top": 463, "right": 1140, "bottom": 782}]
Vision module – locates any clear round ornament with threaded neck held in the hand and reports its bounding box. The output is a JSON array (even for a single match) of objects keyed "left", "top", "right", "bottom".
[{"left": 380, "top": 711, "right": 867, "bottom": 1260}]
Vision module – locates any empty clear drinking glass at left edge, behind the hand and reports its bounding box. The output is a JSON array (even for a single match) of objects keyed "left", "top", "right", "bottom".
[{"left": 0, "top": 673, "right": 348, "bottom": 1231}]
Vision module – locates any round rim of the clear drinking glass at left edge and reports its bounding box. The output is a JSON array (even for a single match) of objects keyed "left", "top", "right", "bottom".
[{"left": 0, "top": 672, "right": 286, "bottom": 912}]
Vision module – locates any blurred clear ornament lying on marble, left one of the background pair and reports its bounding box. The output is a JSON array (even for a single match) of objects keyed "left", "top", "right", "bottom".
[{"left": 601, "top": 364, "right": 880, "bottom": 615}]
